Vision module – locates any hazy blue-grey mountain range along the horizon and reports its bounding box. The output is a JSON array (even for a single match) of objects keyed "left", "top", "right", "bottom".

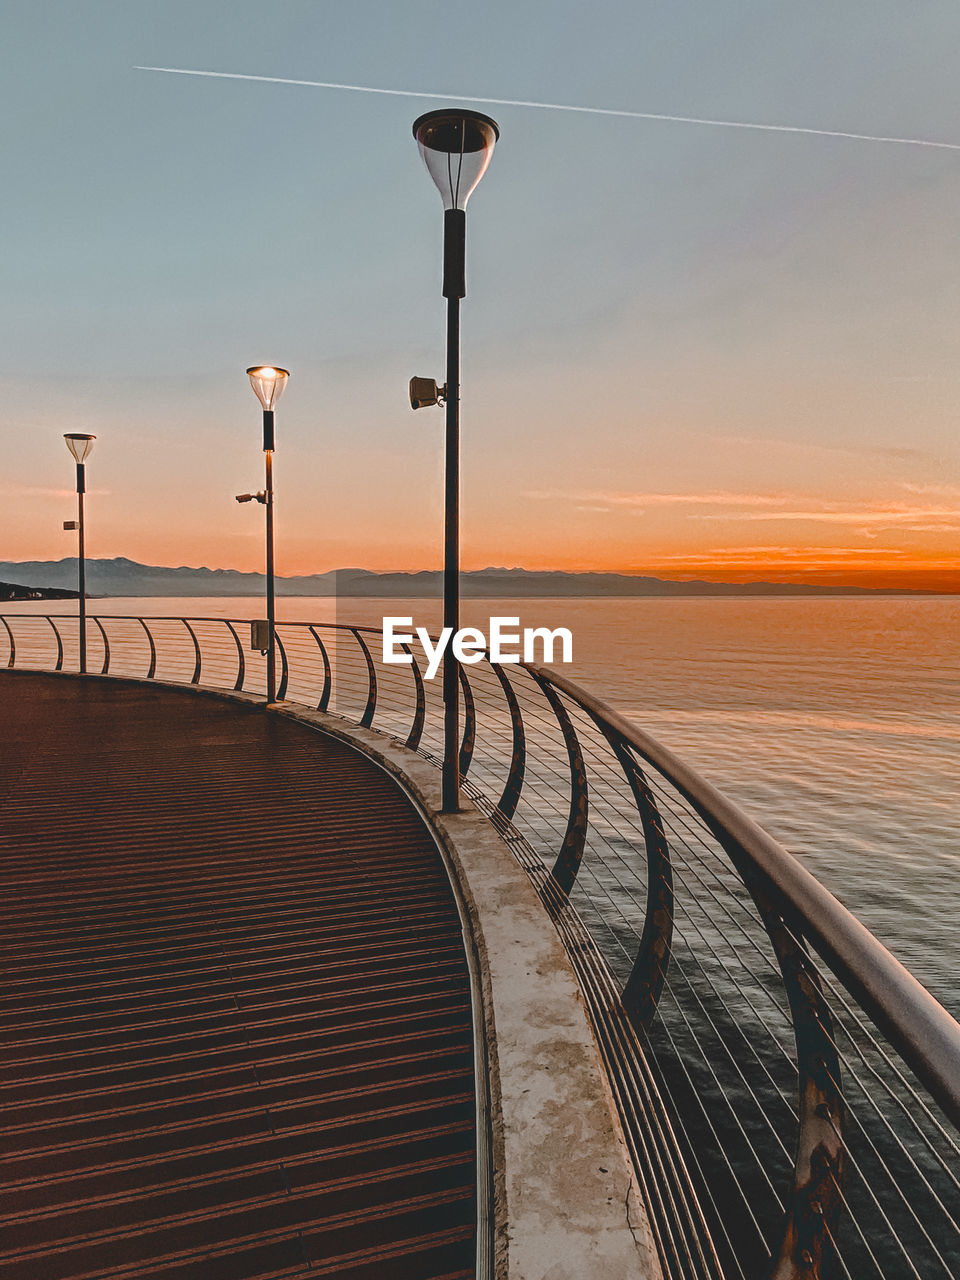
[{"left": 0, "top": 556, "right": 936, "bottom": 599}]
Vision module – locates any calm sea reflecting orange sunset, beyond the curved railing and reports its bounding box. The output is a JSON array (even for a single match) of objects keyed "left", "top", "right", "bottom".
[{"left": 8, "top": 596, "right": 960, "bottom": 1012}]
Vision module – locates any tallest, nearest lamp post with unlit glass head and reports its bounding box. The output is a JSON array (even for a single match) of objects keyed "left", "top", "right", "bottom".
[{"left": 411, "top": 108, "right": 500, "bottom": 813}]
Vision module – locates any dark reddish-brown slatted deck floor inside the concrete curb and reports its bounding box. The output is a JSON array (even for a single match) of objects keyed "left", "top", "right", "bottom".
[{"left": 0, "top": 672, "right": 475, "bottom": 1280}]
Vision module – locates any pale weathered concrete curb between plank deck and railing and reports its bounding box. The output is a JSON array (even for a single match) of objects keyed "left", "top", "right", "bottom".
[{"left": 8, "top": 671, "right": 662, "bottom": 1280}]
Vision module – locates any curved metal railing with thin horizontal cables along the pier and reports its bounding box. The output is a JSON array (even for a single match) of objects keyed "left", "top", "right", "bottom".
[{"left": 0, "top": 613, "right": 960, "bottom": 1280}]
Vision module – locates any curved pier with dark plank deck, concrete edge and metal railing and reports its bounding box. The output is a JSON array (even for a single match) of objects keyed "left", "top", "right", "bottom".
[{"left": 0, "top": 614, "right": 960, "bottom": 1280}]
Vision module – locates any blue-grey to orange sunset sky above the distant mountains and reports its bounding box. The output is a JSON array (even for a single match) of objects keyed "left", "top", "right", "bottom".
[{"left": 0, "top": 0, "right": 960, "bottom": 590}]
